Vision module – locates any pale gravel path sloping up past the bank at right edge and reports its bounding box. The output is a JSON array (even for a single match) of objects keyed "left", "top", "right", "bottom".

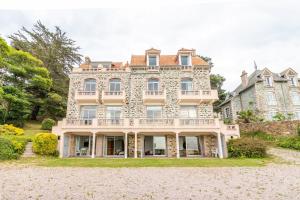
[{"left": 268, "top": 148, "right": 300, "bottom": 165}]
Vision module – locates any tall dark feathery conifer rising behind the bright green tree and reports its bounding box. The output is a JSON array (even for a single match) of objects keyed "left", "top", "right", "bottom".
[{"left": 9, "top": 21, "right": 82, "bottom": 115}]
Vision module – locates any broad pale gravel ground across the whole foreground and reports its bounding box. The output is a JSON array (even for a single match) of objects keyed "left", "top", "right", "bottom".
[{"left": 0, "top": 165, "right": 300, "bottom": 200}]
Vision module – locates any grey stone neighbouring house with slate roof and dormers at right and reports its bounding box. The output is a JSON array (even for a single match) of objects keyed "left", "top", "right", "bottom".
[{"left": 219, "top": 68, "right": 300, "bottom": 120}]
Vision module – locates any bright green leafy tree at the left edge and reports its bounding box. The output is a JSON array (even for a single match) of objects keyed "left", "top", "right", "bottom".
[{"left": 0, "top": 38, "right": 52, "bottom": 126}]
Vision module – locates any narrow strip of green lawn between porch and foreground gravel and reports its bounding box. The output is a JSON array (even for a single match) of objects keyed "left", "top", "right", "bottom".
[{"left": 0, "top": 157, "right": 272, "bottom": 168}]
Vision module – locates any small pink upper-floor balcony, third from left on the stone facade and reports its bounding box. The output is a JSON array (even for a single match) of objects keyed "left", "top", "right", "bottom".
[{"left": 143, "top": 90, "right": 166, "bottom": 105}]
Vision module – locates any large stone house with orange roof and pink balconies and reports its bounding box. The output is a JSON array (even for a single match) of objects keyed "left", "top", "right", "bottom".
[{"left": 52, "top": 48, "right": 239, "bottom": 158}]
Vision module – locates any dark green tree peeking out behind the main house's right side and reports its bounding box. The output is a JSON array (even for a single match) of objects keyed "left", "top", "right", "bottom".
[{"left": 200, "top": 56, "right": 227, "bottom": 111}]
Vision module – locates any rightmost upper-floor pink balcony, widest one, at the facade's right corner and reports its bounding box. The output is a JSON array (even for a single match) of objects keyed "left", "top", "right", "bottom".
[{"left": 178, "top": 90, "right": 219, "bottom": 104}]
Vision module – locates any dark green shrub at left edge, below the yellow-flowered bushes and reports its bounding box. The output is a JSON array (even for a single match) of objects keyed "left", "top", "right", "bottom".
[{"left": 0, "top": 138, "right": 20, "bottom": 160}]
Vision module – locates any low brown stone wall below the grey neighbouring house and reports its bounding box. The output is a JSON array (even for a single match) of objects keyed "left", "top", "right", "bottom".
[{"left": 239, "top": 120, "right": 300, "bottom": 135}]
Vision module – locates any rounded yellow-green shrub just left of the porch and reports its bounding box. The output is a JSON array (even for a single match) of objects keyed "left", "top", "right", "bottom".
[{"left": 33, "top": 133, "right": 58, "bottom": 156}]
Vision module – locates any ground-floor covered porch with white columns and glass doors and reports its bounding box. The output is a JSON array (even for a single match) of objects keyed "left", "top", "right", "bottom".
[{"left": 59, "top": 132, "right": 226, "bottom": 158}]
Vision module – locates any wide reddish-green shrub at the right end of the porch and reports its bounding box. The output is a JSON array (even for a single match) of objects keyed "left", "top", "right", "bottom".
[{"left": 227, "top": 138, "right": 267, "bottom": 158}]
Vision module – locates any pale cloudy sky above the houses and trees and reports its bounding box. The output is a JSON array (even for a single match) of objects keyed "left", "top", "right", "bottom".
[{"left": 0, "top": 0, "right": 300, "bottom": 91}]
